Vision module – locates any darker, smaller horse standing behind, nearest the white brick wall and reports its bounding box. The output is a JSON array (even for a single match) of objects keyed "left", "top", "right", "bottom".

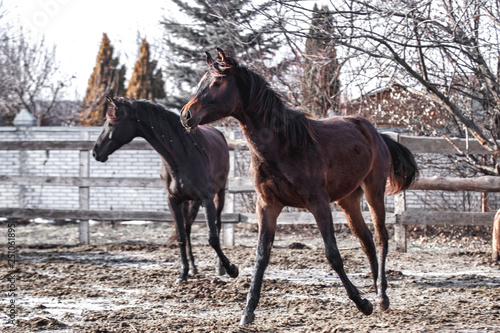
[{"left": 93, "top": 97, "right": 238, "bottom": 281}]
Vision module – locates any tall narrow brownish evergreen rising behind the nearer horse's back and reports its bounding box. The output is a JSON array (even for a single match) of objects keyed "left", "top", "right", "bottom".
[{"left": 301, "top": 4, "right": 340, "bottom": 118}]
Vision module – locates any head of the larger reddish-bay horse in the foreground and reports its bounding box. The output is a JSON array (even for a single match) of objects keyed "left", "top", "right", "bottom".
[{"left": 181, "top": 48, "right": 241, "bottom": 129}]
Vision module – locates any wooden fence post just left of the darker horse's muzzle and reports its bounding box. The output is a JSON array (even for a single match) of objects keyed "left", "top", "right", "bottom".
[{"left": 78, "top": 131, "right": 90, "bottom": 245}]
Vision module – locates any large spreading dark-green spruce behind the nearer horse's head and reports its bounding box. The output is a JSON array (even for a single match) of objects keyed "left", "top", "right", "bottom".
[{"left": 162, "top": 0, "right": 280, "bottom": 108}]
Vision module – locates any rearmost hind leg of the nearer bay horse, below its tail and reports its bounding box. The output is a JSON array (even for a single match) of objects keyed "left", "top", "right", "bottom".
[{"left": 365, "top": 179, "right": 389, "bottom": 310}]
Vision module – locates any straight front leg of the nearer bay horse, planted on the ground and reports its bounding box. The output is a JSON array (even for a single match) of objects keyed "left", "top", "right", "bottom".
[{"left": 240, "top": 197, "right": 283, "bottom": 325}]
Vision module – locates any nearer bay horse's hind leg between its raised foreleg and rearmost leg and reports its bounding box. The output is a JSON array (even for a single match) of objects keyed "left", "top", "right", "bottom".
[{"left": 337, "top": 188, "right": 378, "bottom": 290}]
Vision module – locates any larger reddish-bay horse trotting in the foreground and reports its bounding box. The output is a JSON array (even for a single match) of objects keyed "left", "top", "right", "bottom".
[{"left": 181, "top": 48, "right": 418, "bottom": 325}]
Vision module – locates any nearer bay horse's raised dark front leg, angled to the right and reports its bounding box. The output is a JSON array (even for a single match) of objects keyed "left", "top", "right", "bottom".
[{"left": 309, "top": 195, "right": 373, "bottom": 315}]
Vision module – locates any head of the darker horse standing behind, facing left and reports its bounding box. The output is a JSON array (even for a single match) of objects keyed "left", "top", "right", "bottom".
[{"left": 92, "top": 97, "right": 137, "bottom": 162}]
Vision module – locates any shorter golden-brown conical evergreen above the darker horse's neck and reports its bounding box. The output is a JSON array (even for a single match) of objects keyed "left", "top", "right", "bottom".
[{"left": 125, "top": 39, "right": 166, "bottom": 99}]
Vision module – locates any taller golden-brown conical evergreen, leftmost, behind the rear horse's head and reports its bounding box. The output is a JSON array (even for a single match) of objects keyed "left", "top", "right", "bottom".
[{"left": 80, "top": 34, "right": 126, "bottom": 126}]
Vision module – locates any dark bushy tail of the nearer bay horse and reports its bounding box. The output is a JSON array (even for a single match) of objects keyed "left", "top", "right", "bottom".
[{"left": 381, "top": 134, "right": 418, "bottom": 195}]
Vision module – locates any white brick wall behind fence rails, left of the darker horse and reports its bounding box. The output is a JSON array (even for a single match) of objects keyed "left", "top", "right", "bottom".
[{"left": 0, "top": 127, "right": 168, "bottom": 211}]
